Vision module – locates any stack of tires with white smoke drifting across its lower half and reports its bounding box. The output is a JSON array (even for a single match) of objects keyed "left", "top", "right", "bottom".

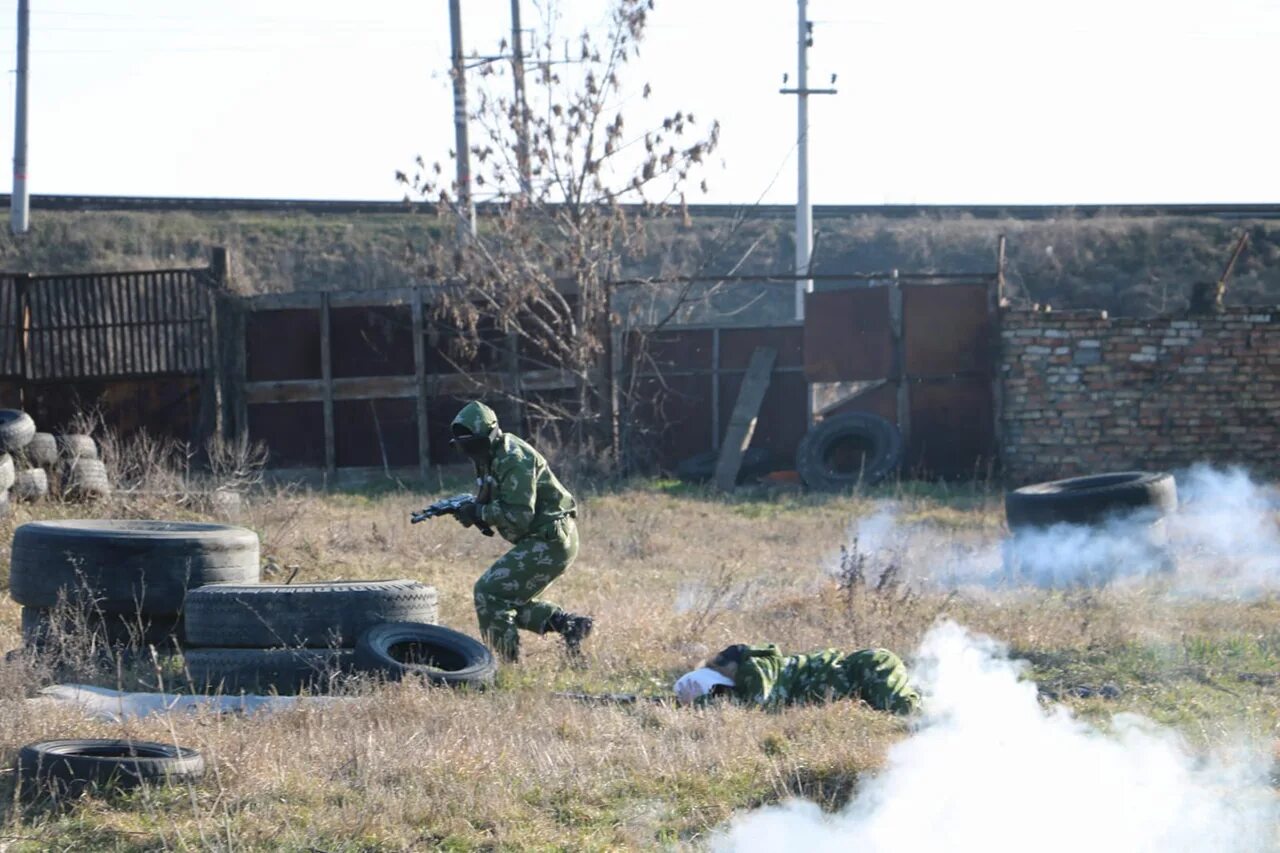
[{"left": 1004, "top": 471, "right": 1178, "bottom": 585}]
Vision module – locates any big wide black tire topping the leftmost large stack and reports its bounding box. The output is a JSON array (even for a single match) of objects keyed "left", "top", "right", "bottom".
[{"left": 9, "top": 520, "right": 259, "bottom": 613}]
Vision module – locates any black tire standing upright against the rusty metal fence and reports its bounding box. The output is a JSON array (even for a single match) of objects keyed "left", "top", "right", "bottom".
[{"left": 796, "top": 411, "right": 902, "bottom": 492}]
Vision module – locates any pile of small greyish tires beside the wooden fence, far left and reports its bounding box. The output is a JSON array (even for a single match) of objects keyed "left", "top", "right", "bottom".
[{"left": 0, "top": 409, "right": 111, "bottom": 515}]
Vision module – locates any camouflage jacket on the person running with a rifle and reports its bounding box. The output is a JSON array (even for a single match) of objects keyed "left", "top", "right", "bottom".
[{"left": 476, "top": 433, "right": 576, "bottom": 542}]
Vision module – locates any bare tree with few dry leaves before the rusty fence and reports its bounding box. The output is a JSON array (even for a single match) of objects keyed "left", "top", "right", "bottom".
[{"left": 398, "top": 0, "right": 719, "bottom": 466}]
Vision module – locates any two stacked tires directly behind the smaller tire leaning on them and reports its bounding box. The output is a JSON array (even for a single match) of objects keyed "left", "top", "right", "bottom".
[{"left": 183, "top": 580, "right": 455, "bottom": 694}]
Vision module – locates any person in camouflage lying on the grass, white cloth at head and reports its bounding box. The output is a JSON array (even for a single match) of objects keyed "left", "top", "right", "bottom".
[{"left": 676, "top": 643, "right": 920, "bottom": 713}]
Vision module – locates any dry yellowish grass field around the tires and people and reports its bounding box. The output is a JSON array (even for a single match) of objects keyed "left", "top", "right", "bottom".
[{"left": 0, "top": 468, "right": 1280, "bottom": 852}]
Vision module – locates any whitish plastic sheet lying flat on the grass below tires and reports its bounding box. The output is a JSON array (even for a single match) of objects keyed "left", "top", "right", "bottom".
[{"left": 29, "top": 684, "right": 351, "bottom": 722}]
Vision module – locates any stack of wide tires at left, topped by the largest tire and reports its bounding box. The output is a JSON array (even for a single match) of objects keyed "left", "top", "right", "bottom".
[{"left": 9, "top": 520, "right": 260, "bottom": 651}]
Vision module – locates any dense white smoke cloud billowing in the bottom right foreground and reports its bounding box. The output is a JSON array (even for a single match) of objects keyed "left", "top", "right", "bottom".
[{"left": 713, "top": 622, "right": 1280, "bottom": 853}]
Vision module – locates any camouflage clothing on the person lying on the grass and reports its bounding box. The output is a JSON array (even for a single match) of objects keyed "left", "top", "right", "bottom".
[{"left": 732, "top": 643, "right": 920, "bottom": 713}]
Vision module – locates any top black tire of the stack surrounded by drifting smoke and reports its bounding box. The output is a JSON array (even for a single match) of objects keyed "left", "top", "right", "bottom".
[{"left": 1005, "top": 471, "right": 1178, "bottom": 530}]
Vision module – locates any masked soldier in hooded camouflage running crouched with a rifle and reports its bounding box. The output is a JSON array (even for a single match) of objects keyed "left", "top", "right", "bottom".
[{"left": 452, "top": 401, "right": 593, "bottom": 661}]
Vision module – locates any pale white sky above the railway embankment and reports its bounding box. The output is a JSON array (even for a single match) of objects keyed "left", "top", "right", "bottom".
[{"left": 0, "top": 0, "right": 1280, "bottom": 204}]
